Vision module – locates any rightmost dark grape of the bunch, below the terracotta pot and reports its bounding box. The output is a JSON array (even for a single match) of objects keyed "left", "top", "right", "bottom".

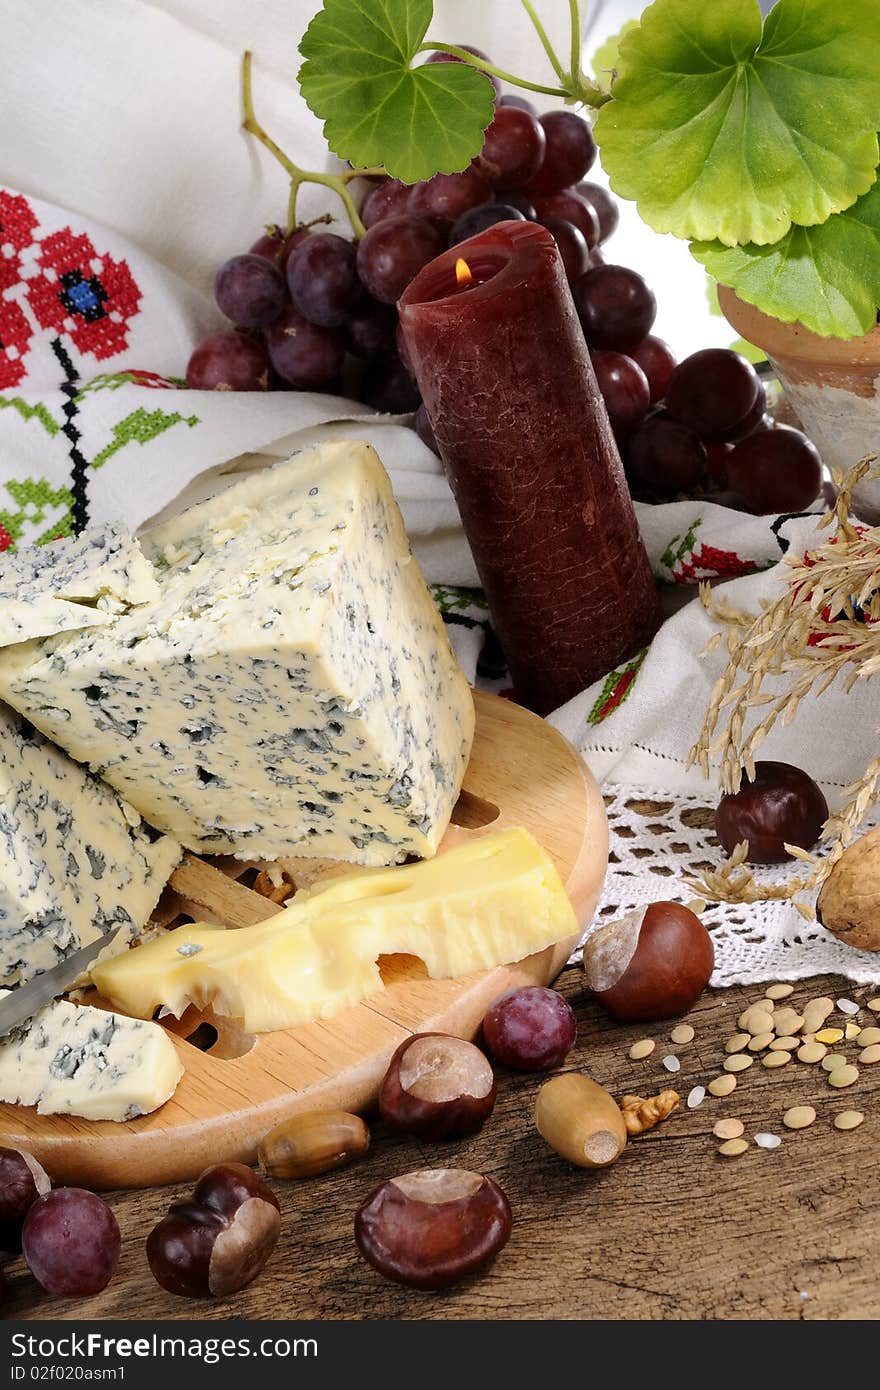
[{"left": 726, "top": 425, "right": 822, "bottom": 516}]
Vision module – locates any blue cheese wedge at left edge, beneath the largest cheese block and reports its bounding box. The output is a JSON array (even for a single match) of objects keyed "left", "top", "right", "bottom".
[{"left": 0, "top": 705, "right": 181, "bottom": 988}]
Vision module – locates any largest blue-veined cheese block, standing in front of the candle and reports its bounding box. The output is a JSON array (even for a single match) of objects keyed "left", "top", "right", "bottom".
[{"left": 0, "top": 441, "right": 474, "bottom": 865}]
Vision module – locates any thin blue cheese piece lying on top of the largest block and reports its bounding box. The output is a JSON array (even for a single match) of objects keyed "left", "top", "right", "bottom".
[{"left": 0, "top": 524, "right": 158, "bottom": 646}]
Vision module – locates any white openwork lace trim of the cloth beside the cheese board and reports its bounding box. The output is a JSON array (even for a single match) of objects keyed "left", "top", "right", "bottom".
[{"left": 576, "top": 785, "right": 880, "bottom": 987}]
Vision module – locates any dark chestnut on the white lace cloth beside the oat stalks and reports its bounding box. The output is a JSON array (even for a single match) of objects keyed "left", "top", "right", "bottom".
[{"left": 715, "top": 763, "right": 829, "bottom": 865}]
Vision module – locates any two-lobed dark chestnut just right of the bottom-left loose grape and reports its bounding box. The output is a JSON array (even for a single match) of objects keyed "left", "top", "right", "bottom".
[{"left": 146, "top": 1163, "right": 281, "bottom": 1298}]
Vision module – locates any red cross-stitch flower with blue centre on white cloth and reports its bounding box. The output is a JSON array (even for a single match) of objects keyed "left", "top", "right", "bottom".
[{"left": 28, "top": 227, "right": 140, "bottom": 360}]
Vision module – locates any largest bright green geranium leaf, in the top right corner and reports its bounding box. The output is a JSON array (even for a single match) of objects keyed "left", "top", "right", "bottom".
[{"left": 595, "top": 0, "right": 880, "bottom": 246}]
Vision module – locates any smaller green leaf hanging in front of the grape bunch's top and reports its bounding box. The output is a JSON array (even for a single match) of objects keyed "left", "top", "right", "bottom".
[{"left": 299, "top": 0, "right": 495, "bottom": 183}]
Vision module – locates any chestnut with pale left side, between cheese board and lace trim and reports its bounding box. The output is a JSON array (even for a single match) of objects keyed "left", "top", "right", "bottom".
[{"left": 584, "top": 902, "right": 715, "bottom": 1023}]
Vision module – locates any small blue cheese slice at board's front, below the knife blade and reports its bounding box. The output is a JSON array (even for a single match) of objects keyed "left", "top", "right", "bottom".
[{"left": 0, "top": 990, "right": 184, "bottom": 1120}]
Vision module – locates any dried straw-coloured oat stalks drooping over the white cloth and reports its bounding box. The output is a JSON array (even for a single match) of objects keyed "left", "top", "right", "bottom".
[{"left": 687, "top": 455, "right": 880, "bottom": 917}]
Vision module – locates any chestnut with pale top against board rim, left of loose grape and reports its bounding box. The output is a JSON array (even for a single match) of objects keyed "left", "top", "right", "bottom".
[{"left": 380, "top": 1033, "right": 496, "bottom": 1138}]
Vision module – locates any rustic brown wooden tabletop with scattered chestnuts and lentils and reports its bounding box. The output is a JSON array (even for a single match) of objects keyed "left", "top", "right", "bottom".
[{"left": 3, "top": 969, "right": 880, "bottom": 1321}]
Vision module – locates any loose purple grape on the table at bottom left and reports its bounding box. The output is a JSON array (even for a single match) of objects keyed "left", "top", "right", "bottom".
[{"left": 21, "top": 1187, "right": 122, "bottom": 1298}]
